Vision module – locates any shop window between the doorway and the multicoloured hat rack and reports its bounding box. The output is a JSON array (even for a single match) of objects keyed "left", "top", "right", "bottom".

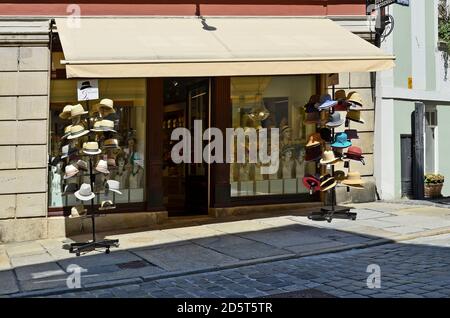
[{"left": 230, "top": 75, "right": 316, "bottom": 197}]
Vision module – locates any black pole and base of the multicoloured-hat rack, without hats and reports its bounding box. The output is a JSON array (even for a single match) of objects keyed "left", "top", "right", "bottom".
[{"left": 308, "top": 85, "right": 357, "bottom": 223}]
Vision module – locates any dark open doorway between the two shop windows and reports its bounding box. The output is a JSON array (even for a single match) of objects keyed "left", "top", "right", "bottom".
[{"left": 162, "top": 78, "right": 210, "bottom": 216}]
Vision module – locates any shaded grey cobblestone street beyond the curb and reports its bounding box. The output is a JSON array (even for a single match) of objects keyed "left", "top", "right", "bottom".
[{"left": 46, "top": 234, "right": 450, "bottom": 298}]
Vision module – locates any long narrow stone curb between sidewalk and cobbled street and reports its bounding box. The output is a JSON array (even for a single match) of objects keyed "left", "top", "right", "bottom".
[{"left": 4, "top": 227, "right": 450, "bottom": 298}]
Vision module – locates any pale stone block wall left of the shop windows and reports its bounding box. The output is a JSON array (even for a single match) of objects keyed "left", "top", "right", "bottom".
[{"left": 0, "top": 19, "right": 50, "bottom": 242}]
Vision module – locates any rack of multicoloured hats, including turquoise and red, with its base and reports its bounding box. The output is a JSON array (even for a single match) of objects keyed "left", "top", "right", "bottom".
[{"left": 305, "top": 85, "right": 364, "bottom": 222}]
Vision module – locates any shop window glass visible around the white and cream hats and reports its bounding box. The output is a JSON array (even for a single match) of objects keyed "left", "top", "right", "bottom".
[{"left": 48, "top": 79, "right": 146, "bottom": 208}]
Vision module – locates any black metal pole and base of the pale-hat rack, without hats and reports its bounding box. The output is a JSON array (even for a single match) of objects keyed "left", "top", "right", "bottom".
[{"left": 69, "top": 101, "right": 119, "bottom": 256}]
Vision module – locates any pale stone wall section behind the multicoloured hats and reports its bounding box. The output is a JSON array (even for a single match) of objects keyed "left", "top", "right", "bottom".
[{"left": 329, "top": 73, "right": 377, "bottom": 203}]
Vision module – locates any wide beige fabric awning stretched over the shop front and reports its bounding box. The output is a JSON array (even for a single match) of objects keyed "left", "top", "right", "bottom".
[{"left": 56, "top": 17, "right": 394, "bottom": 78}]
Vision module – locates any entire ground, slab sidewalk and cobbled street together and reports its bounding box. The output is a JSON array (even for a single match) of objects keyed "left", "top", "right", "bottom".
[{"left": 0, "top": 203, "right": 450, "bottom": 297}]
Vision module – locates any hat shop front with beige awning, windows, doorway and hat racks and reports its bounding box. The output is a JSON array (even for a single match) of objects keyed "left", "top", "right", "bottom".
[{"left": 48, "top": 17, "right": 394, "bottom": 235}]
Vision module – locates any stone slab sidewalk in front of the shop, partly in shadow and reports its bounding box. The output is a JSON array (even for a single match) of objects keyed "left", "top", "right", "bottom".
[{"left": 0, "top": 202, "right": 450, "bottom": 296}]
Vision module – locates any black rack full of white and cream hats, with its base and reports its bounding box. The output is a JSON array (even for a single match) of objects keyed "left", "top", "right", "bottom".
[{"left": 60, "top": 100, "right": 120, "bottom": 256}]
